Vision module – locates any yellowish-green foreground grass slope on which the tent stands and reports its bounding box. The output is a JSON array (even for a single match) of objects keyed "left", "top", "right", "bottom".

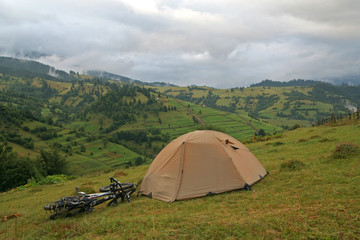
[{"left": 0, "top": 121, "right": 360, "bottom": 239}]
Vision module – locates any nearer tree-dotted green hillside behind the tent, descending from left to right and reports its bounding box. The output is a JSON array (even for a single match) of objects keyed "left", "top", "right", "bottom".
[{"left": 0, "top": 74, "right": 281, "bottom": 175}]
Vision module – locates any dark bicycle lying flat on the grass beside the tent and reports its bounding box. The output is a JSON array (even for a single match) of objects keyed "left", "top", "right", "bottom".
[{"left": 44, "top": 177, "right": 137, "bottom": 219}]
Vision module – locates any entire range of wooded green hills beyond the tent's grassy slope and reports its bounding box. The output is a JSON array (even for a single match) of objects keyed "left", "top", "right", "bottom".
[{"left": 0, "top": 57, "right": 360, "bottom": 191}]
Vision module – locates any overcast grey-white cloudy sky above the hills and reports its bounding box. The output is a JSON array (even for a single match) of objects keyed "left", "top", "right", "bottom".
[{"left": 0, "top": 0, "right": 360, "bottom": 88}]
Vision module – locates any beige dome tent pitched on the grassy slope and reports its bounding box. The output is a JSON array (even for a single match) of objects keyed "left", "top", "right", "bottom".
[{"left": 140, "top": 130, "right": 267, "bottom": 202}]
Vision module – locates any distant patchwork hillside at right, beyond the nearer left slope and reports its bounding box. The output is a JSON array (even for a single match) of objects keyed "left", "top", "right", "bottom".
[{"left": 157, "top": 82, "right": 360, "bottom": 128}]
